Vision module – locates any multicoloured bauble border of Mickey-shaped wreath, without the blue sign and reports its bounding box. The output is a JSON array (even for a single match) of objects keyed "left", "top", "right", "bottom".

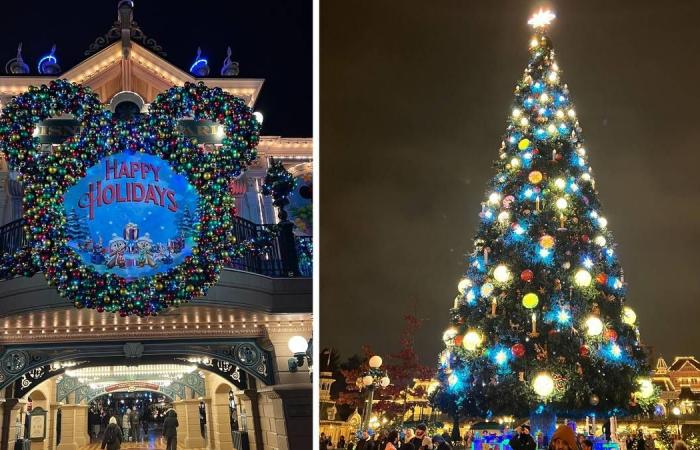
[{"left": 0, "top": 80, "right": 266, "bottom": 315}]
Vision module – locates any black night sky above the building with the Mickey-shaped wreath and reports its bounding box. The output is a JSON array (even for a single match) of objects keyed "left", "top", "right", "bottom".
[{"left": 0, "top": 0, "right": 313, "bottom": 137}]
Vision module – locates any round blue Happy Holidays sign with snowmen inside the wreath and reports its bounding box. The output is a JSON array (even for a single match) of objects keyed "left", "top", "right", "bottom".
[{"left": 63, "top": 152, "right": 199, "bottom": 279}]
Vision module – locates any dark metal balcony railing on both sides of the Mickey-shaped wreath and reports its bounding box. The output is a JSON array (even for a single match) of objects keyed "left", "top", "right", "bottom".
[{"left": 0, "top": 217, "right": 313, "bottom": 278}]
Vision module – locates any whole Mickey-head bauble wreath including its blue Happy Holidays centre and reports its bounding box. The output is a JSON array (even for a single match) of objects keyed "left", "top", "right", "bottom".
[{"left": 0, "top": 80, "right": 260, "bottom": 316}]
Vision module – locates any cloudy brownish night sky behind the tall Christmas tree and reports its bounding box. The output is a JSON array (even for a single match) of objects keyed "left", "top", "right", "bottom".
[{"left": 320, "top": 0, "right": 700, "bottom": 364}]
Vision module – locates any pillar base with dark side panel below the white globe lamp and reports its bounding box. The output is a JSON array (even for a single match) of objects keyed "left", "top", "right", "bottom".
[{"left": 258, "top": 383, "right": 314, "bottom": 450}]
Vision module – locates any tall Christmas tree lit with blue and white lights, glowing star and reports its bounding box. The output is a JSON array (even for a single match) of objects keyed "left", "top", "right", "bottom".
[{"left": 433, "top": 12, "right": 654, "bottom": 431}]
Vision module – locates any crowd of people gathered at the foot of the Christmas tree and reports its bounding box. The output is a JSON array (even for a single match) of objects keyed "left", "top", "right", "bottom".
[{"left": 320, "top": 424, "right": 688, "bottom": 450}]
